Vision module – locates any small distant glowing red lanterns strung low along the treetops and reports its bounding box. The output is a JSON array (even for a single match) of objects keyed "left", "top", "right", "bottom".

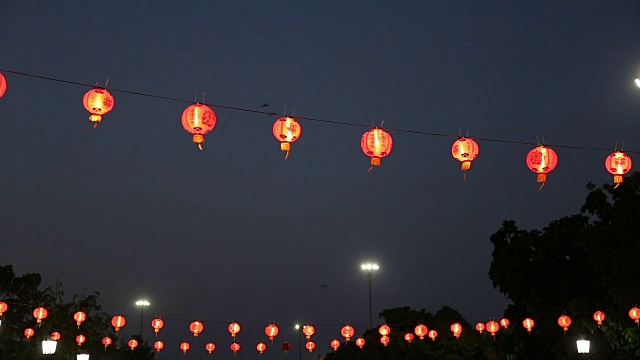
[{"left": 0, "top": 302, "right": 640, "bottom": 354}]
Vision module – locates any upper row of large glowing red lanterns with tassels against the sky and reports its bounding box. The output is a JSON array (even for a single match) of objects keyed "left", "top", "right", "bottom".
[{"left": 0, "top": 73, "right": 632, "bottom": 188}]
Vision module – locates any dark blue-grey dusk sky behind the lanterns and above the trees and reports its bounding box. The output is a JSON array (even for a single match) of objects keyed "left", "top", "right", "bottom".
[{"left": 0, "top": 0, "right": 640, "bottom": 360}]
